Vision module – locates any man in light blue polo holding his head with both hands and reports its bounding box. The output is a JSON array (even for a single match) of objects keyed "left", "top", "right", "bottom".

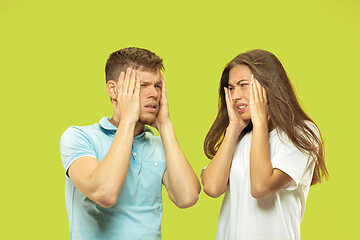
[{"left": 60, "top": 48, "right": 200, "bottom": 239}]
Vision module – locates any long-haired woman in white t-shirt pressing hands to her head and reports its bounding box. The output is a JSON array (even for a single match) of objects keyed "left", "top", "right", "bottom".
[{"left": 201, "top": 50, "right": 328, "bottom": 240}]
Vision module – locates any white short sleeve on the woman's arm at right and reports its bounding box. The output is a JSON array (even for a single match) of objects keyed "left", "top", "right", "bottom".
[{"left": 271, "top": 130, "right": 310, "bottom": 190}]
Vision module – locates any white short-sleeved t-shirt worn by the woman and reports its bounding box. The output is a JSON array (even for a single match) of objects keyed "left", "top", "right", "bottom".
[{"left": 216, "top": 126, "right": 315, "bottom": 240}]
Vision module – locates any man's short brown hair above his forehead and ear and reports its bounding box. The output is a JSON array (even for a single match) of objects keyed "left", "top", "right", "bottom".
[{"left": 105, "top": 47, "right": 165, "bottom": 82}]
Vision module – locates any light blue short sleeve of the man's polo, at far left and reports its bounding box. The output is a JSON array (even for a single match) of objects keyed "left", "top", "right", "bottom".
[{"left": 60, "top": 127, "right": 96, "bottom": 176}]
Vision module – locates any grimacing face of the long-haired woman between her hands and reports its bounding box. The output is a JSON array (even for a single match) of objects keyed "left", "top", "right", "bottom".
[{"left": 229, "top": 65, "right": 252, "bottom": 120}]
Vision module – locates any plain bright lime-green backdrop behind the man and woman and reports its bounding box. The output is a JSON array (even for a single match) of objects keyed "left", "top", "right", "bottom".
[{"left": 0, "top": 0, "right": 360, "bottom": 240}]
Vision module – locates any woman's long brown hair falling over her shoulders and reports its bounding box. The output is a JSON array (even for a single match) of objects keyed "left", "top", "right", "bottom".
[{"left": 204, "top": 49, "right": 329, "bottom": 185}]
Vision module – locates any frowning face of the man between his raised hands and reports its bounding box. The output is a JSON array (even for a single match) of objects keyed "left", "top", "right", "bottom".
[{"left": 137, "top": 67, "right": 162, "bottom": 125}]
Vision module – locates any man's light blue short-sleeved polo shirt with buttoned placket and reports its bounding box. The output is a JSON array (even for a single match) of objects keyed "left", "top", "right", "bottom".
[{"left": 60, "top": 117, "right": 165, "bottom": 240}]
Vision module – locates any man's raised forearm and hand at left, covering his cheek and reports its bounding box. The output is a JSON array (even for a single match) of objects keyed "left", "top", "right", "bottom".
[{"left": 86, "top": 68, "right": 143, "bottom": 205}]
